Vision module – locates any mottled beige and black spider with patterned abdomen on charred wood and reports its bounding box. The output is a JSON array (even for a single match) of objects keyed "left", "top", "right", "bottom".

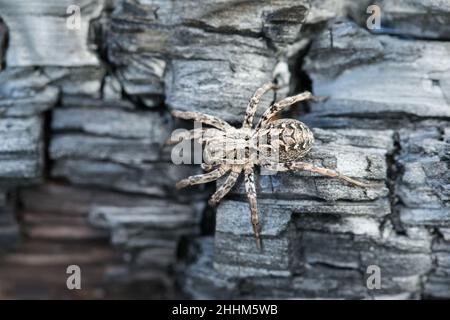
[{"left": 168, "top": 83, "right": 381, "bottom": 250}]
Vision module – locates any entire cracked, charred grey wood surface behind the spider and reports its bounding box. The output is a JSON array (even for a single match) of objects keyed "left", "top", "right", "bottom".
[{"left": 0, "top": 0, "right": 450, "bottom": 299}]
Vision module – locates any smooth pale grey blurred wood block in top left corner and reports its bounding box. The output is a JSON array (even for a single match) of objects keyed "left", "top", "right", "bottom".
[{"left": 0, "top": 0, "right": 103, "bottom": 67}]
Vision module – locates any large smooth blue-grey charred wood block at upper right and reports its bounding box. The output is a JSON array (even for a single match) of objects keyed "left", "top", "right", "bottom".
[{"left": 304, "top": 21, "right": 450, "bottom": 128}]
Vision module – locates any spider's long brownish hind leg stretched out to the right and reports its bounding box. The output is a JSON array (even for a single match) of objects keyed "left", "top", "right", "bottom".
[{"left": 264, "top": 162, "right": 383, "bottom": 188}]
